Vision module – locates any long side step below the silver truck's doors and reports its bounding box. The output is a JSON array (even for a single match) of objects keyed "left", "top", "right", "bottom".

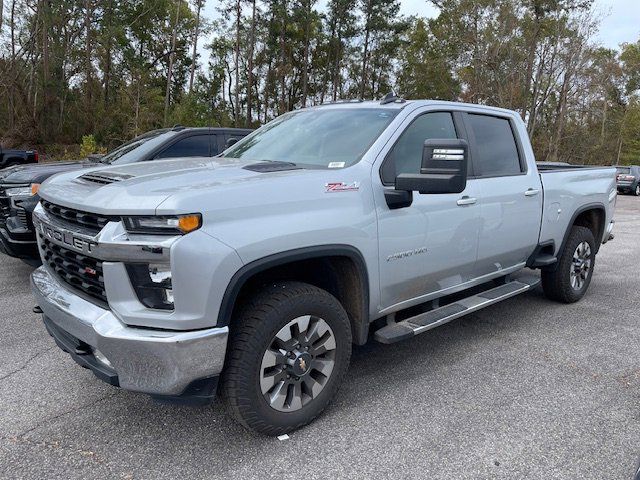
[{"left": 374, "top": 275, "right": 540, "bottom": 343}]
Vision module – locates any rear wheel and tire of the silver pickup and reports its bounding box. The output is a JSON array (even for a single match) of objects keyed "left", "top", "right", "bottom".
[{"left": 542, "top": 225, "right": 596, "bottom": 303}]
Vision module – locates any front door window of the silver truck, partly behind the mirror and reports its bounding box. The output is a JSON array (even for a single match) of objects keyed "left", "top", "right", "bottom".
[{"left": 382, "top": 112, "right": 457, "bottom": 183}]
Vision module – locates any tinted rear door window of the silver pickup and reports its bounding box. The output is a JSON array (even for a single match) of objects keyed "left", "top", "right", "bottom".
[{"left": 467, "top": 114, "right": 522, "bottom": 176}]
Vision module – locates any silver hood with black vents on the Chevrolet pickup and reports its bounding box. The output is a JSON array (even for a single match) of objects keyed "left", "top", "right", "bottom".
[{"left": 39, "top": 157, "right": 304, "bottom": 215}]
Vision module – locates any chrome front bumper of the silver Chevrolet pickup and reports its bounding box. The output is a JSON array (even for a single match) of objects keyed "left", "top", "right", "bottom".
[{"left": 31, "top": 267, "right": 229, "bottom": 397}]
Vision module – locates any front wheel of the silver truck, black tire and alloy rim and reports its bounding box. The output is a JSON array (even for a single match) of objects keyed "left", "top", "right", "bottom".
[{"left": 220, "top": 282, "right": 351, "bottom": 435}]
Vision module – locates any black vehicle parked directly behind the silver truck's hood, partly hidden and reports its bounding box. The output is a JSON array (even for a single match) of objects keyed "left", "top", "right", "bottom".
[{"left": 0, "top": 126, "right": 252, "bottom": 265}]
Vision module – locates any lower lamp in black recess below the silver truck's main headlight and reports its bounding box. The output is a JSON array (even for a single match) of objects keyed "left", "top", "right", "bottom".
[{"left": 127, "top": 263, "right": 173, "bottom": 310}]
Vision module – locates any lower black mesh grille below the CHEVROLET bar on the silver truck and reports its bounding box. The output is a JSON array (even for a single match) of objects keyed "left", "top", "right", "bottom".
[{"left": 40, "top": 234, "right": 107, "bottom": 303}]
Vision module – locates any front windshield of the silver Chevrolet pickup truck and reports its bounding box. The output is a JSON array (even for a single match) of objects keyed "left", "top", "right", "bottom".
[{"left": 224, "top": 108, "right": 397, "bottom": 168}]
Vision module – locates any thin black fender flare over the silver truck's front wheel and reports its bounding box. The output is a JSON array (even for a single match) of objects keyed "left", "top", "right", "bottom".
[{"left": 217, "top": 244, "right": 370, "bottom": 344}]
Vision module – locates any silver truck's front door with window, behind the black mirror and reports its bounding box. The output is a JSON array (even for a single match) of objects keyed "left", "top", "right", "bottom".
[{"left": 373, "top": 111, "right": 480, "bottom": 313}]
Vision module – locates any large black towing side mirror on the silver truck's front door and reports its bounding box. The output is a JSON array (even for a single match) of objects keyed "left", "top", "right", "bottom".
[{"left": 396, "top": 139, "right": 469, "bottom": 193}]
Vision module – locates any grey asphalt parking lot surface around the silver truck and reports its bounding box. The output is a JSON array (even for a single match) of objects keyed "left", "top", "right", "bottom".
[{"left": 0, "top": 196, "right": 640, "bottom": 480}]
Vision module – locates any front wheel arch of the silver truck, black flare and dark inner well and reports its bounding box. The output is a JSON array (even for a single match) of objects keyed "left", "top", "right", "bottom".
[{"left": 218, "top": 244, "right": 369, "bottom": 345}]
